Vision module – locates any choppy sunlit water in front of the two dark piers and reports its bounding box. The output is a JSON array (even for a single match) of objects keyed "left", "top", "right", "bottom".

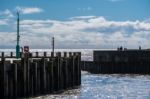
[{"left": 30, "top": 72, "right": 150, "bottom": 99}]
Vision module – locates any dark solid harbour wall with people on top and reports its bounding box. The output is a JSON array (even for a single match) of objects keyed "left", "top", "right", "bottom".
[{"left": 81, "top": 50, "right": 150, "bottom": 74}]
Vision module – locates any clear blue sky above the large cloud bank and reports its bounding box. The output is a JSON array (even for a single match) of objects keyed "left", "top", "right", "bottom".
[{"left": 0, "top": 0, "right": 150, "bottom": 20}]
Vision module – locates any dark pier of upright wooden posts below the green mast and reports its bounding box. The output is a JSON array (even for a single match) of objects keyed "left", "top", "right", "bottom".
[{"left": 0, "top": 52, "right": 81, "bottom": 99}]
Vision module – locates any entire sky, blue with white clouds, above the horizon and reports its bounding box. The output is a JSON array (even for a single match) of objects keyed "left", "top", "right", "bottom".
[{"left": 0, "top": 0, "right": 150, "bottom": 49}]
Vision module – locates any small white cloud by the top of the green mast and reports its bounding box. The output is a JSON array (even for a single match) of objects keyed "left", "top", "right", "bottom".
[{"left": 15, "top": 6, "right": 43, "bottom": 14}]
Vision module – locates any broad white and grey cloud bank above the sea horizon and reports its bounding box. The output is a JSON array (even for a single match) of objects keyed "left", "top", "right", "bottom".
[{"left": 0, "top": 16, "right": 150, "bottom": 48}]
